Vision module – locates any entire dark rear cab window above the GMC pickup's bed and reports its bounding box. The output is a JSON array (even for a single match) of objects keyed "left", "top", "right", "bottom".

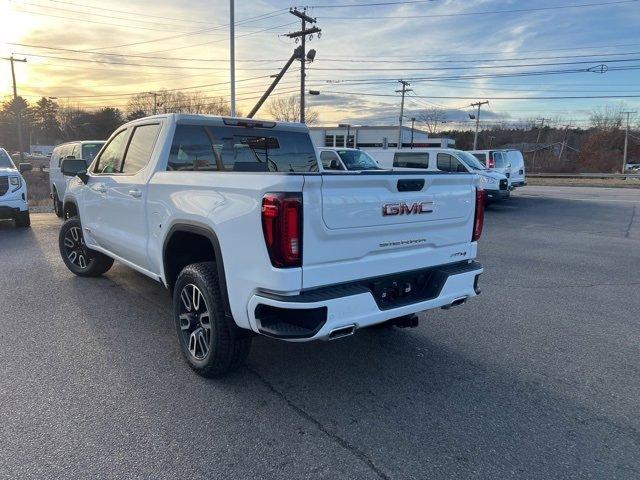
[{"left": 167, "top": 124, "right": 318, "bottom": 173}]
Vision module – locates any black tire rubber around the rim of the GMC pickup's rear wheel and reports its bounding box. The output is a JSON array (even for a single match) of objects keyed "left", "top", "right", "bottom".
[{"left": 173, "top": 262, "right": 252, "bottom": 377}]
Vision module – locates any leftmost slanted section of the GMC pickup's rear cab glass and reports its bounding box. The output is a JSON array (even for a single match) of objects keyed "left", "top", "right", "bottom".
[{"left": 167, "top": 125, "right": 218, "bottom": 171}]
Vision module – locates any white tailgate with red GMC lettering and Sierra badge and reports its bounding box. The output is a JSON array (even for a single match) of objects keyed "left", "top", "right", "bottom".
[{"left": 302, "top": 172, "right": 476, "bottom": 288}]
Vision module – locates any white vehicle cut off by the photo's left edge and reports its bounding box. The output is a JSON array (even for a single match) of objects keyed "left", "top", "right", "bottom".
[{"left": 0, "top": 148, "right": 31, "bottom": 228}]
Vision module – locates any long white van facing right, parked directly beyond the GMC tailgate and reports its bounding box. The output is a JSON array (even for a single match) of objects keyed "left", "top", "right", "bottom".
[{"left": 369, "top": 148, "right": 509, "bottom": 201}]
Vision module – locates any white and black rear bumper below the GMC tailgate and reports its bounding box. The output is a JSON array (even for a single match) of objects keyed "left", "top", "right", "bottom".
[{"left": 248, "top": 261, "right": 483, "bottom": 342}]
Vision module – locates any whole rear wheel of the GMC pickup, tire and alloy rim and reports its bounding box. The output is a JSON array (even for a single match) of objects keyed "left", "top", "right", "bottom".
[{"left": 173, "top": 262, "right": 251, "bottom": 377}]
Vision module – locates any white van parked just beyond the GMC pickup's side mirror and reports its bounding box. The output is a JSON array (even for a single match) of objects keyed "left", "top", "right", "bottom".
[{"left": 49, "top": 140, "right": 105, "bottom": 217}]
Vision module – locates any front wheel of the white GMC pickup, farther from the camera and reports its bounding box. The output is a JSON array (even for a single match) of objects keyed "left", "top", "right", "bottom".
[{"left": 58, "top": 217, "right": 113, "bottom": 277}]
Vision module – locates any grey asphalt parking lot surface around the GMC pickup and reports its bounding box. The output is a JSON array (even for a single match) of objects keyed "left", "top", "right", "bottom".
[{"left": 0, "top": 187, "right": 640, "bottom": 479}]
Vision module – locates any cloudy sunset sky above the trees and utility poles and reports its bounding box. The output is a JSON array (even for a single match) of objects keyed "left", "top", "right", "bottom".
[{"left": 0, "top": 0, "right": 640, "bottom": 125}]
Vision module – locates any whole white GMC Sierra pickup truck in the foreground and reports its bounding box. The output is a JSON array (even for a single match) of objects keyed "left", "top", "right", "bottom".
[{"left": 59, "top": 114, "right": 484, "bottom": 376}]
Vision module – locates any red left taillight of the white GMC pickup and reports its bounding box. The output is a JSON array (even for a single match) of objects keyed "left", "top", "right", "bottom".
[{"left": 262, "top": 193, "right": 302, "bottom": 268}]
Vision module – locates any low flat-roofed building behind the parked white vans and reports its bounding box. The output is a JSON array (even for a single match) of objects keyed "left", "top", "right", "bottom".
[{"left": 309, "top": 125, "right": 455, "bottom": 150}]
